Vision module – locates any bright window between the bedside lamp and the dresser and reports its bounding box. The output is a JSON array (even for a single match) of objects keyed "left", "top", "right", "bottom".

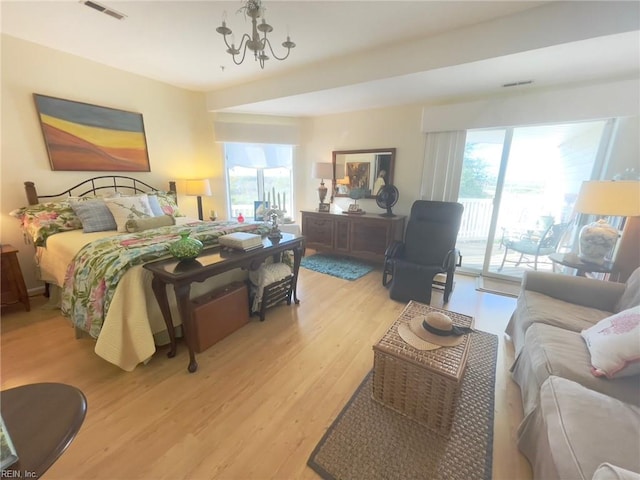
[{"left": 224, "top": 143, "right": 293, "bottom": 220}]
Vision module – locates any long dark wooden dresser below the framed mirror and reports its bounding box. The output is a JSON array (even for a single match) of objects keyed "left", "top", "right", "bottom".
[{"left": 301, "top": 211, "right": 406, "bottom": 263}]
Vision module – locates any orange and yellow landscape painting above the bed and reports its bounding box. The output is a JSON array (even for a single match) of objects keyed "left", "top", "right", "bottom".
[{"left": 33, "top": 93, "right": 151, "bottom": 172}]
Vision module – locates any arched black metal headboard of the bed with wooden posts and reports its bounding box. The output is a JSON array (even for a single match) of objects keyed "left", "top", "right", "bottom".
[{"left": 24, "top": 175, "right": 176, "bottom": 205}]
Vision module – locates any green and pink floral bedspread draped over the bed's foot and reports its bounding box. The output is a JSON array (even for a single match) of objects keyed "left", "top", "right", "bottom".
[{"left": 61, "top": 222, "right": 266, "bottom": 338}]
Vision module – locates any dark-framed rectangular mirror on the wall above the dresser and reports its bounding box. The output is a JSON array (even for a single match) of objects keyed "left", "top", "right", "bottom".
[{"left": 333, "top": 148, "right": 396, "bottom": 198}]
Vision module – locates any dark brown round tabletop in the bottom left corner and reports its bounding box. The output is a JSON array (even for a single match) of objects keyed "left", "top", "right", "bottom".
[{"left": 0, "top": 383, "right": 87, "bottom": 478}]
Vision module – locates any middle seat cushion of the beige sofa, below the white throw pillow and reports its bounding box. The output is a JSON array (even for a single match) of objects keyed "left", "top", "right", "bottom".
[{"left": 512, "top": 323, "right": 640, "bottom": 414}]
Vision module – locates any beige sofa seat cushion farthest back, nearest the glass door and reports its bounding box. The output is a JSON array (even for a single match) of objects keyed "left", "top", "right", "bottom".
[{"left": 506, "top": 290, "right": 613, "bottom": 355}]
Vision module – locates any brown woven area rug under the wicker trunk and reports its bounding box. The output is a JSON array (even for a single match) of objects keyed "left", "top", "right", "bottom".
[{"left": 307, "top": 332, "right": 498, "bottom": 480}]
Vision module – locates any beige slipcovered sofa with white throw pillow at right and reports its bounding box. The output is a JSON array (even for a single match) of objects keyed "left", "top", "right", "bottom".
[{"left": 506, "top": 268, "right": 640, "bottom": 480}]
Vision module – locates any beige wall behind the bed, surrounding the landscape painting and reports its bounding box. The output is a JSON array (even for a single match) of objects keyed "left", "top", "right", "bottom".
[{"left": 0, "top": 35, "right": 219, "bottom": 288}]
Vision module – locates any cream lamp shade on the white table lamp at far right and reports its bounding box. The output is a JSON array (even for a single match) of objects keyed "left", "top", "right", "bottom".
[{"left": 574, "top": 180, "right": 640, "bottom": 217}]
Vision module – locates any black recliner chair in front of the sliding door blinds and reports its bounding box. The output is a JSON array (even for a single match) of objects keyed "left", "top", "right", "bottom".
[{"left": 382, "top": 200, "right": 464, "bottom": 304}]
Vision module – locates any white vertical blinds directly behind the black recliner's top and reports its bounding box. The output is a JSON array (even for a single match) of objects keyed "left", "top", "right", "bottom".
[{"left": 420, "top": 130, "right": 467, "bottom": 202}]
